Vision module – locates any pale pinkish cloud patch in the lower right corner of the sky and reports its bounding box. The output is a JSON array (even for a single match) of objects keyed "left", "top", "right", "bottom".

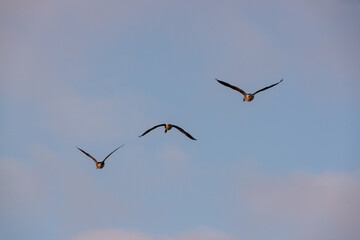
[{"left": 239, "top": 171, "right": 360, "bottom": 239}]
